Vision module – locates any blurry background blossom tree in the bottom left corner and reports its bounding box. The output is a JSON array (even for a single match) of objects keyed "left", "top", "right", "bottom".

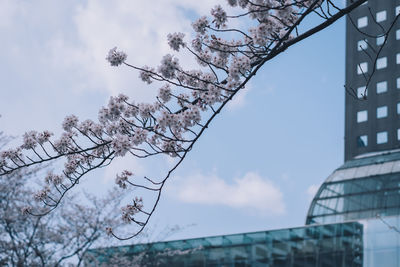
[{"left": 0, "top": 132, "right": 129, "bottom": 266}]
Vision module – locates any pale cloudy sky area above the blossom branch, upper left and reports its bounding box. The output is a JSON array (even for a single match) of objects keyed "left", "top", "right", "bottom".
[{"left": 0, "top": 0, "right": 225, "bottom": 134}]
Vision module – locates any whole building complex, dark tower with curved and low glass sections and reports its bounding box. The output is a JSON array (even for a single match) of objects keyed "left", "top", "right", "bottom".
[{"left": 85, "top": 0, "right": 400, "bottom": 267}]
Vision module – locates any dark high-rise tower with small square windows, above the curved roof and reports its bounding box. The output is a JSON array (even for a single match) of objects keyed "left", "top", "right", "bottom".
[{"left": 345, "top": 0, "right": 400, "bottom": 161}]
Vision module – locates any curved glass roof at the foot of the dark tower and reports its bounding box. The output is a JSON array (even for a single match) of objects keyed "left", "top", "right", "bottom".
[{"left": 306, "top": 150, "right": 400, "bottom": 224}]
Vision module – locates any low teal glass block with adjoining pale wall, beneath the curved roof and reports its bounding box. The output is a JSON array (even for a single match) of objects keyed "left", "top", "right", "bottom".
[{"left": 84, "top": 215, "right": 400, "bottom": 267}]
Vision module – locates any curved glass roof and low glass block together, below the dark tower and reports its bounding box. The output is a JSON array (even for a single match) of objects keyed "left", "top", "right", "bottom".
[{"left": 85, "top": 150, "right": 400, "bottom": 267}]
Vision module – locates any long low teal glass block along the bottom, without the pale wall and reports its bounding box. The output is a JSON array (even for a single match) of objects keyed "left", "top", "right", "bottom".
[{"left": 85, "top": 222, "right": 364, "bottom": 267}]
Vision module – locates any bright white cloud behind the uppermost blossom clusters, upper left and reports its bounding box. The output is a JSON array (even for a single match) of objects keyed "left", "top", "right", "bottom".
[{"left": 44, "top": 0, "right": 228, "bottom": 101}]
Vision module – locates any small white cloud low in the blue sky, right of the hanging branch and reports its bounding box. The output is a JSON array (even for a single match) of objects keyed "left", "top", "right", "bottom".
[{"left": 167, "top": 172, "right": 285, "bottom": 215}]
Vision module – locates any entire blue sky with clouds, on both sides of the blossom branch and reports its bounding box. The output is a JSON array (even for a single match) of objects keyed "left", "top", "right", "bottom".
[{"left": 0, "top": 0, "right": 345, "bottom": 243}]
